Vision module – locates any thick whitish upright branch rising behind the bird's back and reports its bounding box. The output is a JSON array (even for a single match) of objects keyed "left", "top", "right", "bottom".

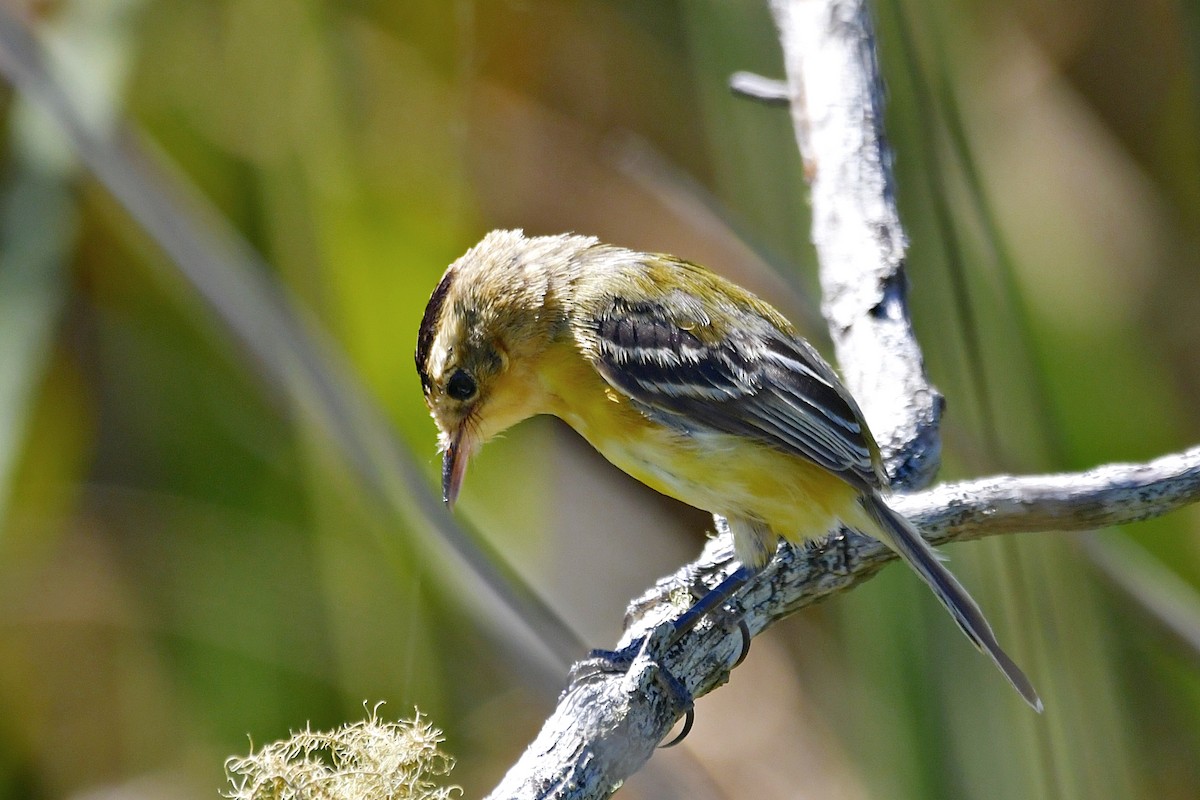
[{"left": 770, "top": 0, "right": 942, "bottom": 488}]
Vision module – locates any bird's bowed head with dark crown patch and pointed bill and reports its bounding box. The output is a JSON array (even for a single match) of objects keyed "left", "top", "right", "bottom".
[{"left": 416, "top": 230, "right": 595, "bottom": 505}]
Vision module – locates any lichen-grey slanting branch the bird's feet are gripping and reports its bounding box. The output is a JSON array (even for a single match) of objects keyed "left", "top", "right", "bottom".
[{"left": 491, "top": 447, "right": 1200, "bottom": 799}]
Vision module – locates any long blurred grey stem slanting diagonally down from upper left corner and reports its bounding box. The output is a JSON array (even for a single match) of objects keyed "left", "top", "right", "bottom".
[{"left": 0, "top": 6, "right": 583, "bottom": 669}]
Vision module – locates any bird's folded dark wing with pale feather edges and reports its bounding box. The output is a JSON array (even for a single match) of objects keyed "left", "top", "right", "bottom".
[{"left": 586, "top": 297, "right": 881, "bottom": 487}]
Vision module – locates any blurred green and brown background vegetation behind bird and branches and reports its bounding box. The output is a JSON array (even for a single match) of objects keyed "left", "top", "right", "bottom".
[{"left": 0, "top": 0, "right": 1200, "bottom": 799}]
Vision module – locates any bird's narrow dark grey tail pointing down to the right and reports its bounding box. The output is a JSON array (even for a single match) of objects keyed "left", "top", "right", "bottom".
[{"left": 860, "top": 492, "right": 1042, "bottom": 712}]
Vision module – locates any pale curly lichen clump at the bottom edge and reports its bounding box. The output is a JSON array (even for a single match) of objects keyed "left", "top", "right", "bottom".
[{"left": 226, "top": 705, "right": 461, "bottom": 800}]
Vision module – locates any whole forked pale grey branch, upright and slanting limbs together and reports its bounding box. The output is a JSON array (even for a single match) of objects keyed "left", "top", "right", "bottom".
[{"left": 490, "top": 0, "right": 1200, "bottom": 799}]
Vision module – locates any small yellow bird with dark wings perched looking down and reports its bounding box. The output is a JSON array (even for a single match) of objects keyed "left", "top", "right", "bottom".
[{"left": 416, "top": 230, "right": 1042, "bottom": 711}]
